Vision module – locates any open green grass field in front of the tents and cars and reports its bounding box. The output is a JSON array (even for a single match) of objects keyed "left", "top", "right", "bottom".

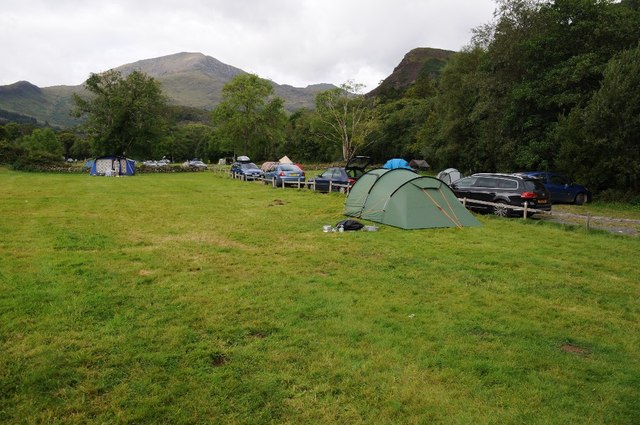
[{"left": 0, "top": 169, "right": 640, "bottom": 424}]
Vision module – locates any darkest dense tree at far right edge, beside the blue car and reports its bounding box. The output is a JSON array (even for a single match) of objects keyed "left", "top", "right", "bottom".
[{"left": 556, "top": 46, "right": 640, "bottom": 195}]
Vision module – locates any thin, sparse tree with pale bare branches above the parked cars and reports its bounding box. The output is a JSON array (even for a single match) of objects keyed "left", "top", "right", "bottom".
[{"left": 316, "top": 81, "right": 379, "bottom": 161}]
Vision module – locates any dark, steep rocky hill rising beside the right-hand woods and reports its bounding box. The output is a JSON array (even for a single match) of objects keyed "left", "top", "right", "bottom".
[{"left": 367, "top": 47, "right": 455, "bottom": 99}]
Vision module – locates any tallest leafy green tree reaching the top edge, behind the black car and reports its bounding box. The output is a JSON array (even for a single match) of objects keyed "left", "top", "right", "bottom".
[{"left": 484, "top": 0, "right": 640, "bottom": 168}]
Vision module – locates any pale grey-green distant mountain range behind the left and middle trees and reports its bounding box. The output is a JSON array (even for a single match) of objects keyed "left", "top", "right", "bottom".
[{"left": 0, "top": 52, "right": 335, "bottom": 127}]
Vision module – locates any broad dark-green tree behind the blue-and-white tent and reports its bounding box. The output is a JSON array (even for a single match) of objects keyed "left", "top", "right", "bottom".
[{"left": 73, "top": 70, "right": 167, "bottom": 157}]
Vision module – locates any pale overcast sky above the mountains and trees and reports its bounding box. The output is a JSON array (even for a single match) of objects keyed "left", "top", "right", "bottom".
[{"left": 0, "top": 0, "right": 495, "bottom": 90}]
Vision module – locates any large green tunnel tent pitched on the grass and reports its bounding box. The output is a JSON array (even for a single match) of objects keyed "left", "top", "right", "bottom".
[{"left": 345, "top": 168, "right": 480, "bottom": 229}]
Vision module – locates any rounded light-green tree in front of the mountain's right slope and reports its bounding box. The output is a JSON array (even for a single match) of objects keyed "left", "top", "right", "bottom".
[{"left": 212, "top": 74, "right": 287, "bottom": 158}]
